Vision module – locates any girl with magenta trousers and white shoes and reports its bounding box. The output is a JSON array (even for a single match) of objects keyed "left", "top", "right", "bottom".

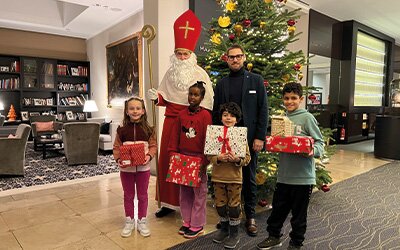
[{"left": 113, "top": 97, "right": 157, "bottom": 237}]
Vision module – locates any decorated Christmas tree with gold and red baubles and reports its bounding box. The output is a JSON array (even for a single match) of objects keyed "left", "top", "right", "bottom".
[{"left": 199, "top": 0, "right": 332, "bottom": 203}]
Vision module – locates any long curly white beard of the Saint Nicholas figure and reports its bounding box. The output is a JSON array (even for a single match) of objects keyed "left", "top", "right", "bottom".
[{"left": 168, "top": 53, "right": 197, "bottom": 90}]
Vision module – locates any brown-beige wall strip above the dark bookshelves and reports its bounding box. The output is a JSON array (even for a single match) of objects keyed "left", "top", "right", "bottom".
[{"left": 0, "top": 28, "right": 87, "bottom": 61}]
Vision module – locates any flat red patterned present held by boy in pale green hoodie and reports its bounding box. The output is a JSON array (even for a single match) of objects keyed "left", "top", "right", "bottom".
[{"left": 266, "top": 136, "right": 314, "bottom": 154}]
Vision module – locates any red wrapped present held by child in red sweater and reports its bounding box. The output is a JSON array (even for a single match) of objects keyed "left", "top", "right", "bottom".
[{"left": 166, "top": 153, "right": 201, "bottom": 187}]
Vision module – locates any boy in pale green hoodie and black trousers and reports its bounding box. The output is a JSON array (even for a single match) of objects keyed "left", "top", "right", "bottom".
[{"left": 257, "top": 83, "right": 324, "bottom": 249}]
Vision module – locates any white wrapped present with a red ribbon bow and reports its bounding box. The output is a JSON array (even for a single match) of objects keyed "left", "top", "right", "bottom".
[{"left": 204, "top": 125, "right": 247, "bottom": 158}]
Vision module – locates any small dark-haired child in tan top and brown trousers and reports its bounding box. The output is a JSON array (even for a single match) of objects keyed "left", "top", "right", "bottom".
[{"left": 209, "top": 102, "right": 251, "bottom": 249}]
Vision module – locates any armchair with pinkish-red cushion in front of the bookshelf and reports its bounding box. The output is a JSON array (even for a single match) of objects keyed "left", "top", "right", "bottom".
[{"left": 30, "top": 115, "right": 63, "bottom": 151}]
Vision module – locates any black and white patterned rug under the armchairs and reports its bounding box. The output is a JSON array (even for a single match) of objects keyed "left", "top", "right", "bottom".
[{"left": 0, "top": 143, "right": 119, "bottom": 192}]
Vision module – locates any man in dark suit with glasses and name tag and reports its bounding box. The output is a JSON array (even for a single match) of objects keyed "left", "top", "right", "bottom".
[{"left": 213, "top": 44, "right": 268, "bottom": 236}]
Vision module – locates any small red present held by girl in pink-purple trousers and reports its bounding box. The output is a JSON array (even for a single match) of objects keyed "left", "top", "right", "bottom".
[{"left": 119, "top": 143, "right": 146, "bottom": 167}]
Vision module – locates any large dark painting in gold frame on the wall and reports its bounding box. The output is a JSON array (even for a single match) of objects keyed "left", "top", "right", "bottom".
[{"left": 106, "top": 32, "right": 143, "bottom": 107}]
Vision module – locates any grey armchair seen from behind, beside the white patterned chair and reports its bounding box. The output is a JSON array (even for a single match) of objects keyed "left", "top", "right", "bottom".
[{"left": 63, "top": 122, "right": 100, "bottom": 165}]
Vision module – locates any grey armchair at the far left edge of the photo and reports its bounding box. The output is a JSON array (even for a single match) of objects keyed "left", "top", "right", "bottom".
[{"left": 0, "top": 124, "right": 31, "bottom": 175}]
